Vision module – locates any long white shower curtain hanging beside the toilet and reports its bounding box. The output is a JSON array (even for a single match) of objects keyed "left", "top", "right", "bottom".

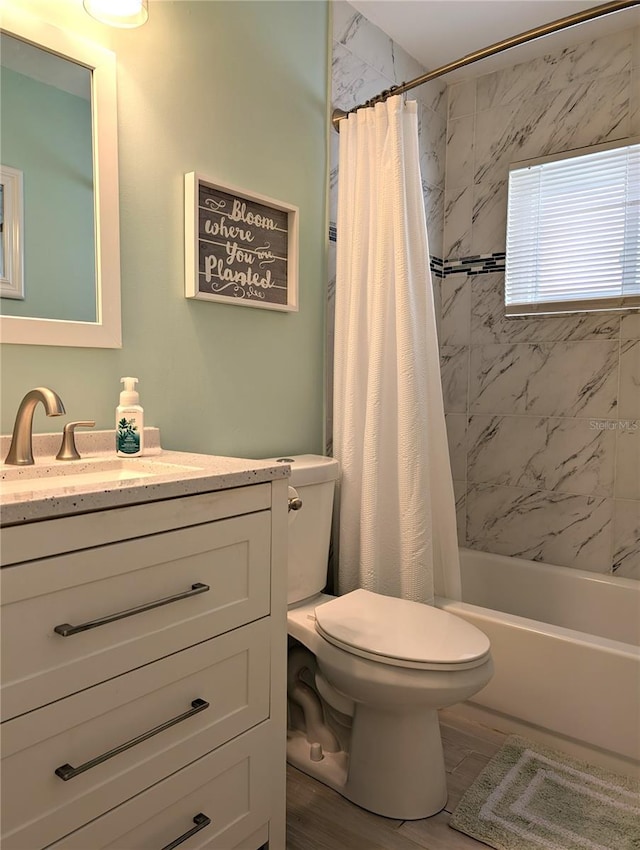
[{"left": 334, "top": 96, "right": 460, "bottom": 603}]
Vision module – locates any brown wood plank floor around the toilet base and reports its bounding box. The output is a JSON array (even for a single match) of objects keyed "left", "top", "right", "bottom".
[{"left": 287, "top": 711, "right": 506, "bottom": 850}]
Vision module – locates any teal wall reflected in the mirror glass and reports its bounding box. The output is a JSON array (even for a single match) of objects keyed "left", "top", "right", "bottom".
[{"left": 0, "top": 68, "right": 96, "bottom": 322}]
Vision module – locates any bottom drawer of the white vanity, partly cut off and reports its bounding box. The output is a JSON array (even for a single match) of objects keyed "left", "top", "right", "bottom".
[{"left": 47, "top": 723, "right": 272, "bottom": 850}]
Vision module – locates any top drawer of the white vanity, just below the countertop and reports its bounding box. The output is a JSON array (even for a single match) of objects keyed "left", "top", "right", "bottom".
[{"left": 0, "top": 511, "right": 271, "bottom": 719}]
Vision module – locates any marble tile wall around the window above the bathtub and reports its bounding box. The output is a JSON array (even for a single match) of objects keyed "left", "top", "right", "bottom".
[{"left": 439, "top": 29, "right": 640, "bottom": 579}]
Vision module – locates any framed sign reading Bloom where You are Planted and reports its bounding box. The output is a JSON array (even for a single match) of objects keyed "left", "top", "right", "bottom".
[{"left": 185, "top": 171, "right": 298, "bottom": 311}]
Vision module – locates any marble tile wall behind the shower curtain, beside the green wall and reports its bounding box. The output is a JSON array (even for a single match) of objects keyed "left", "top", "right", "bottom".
[{"left": 326, "top": 0, "right": 447, "bottom": 453}]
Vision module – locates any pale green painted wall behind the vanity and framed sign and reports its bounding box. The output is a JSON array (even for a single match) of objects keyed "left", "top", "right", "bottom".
[{"left": 1, "top": 0, "right": 329, "bottom": 457}]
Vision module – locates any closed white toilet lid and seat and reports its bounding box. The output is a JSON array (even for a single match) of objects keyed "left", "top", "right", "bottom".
[{"left": 315, "top": 590, "right": 490, "bottom": 669}]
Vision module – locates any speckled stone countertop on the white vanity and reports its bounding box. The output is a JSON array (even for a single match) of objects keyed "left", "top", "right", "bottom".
[{"left": 0, "top": 428, "right": 289, "bottom": 526}]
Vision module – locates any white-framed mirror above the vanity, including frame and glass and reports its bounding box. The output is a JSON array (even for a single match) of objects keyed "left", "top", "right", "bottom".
[{"left": 0, "top": 7, "right": 121, "bottom": 348}]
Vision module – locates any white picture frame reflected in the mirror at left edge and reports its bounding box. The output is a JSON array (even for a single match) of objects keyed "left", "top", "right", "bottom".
[{"left": 0, "top": 165, "right": 24, "bottom": 300}]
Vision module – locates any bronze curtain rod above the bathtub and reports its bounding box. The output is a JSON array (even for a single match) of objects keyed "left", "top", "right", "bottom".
[{"left": 331, "top": 0, "right": 640, "bottom": 132}]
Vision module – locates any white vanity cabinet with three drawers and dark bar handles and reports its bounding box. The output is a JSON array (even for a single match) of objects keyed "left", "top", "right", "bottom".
[{"left": 0, "top": 479, "right": 287, "bottom": 850}]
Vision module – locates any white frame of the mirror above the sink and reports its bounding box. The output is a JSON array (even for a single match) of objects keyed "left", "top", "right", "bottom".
[{"left": 0, "top": 4, "right": 122, "bottom": 348}]
